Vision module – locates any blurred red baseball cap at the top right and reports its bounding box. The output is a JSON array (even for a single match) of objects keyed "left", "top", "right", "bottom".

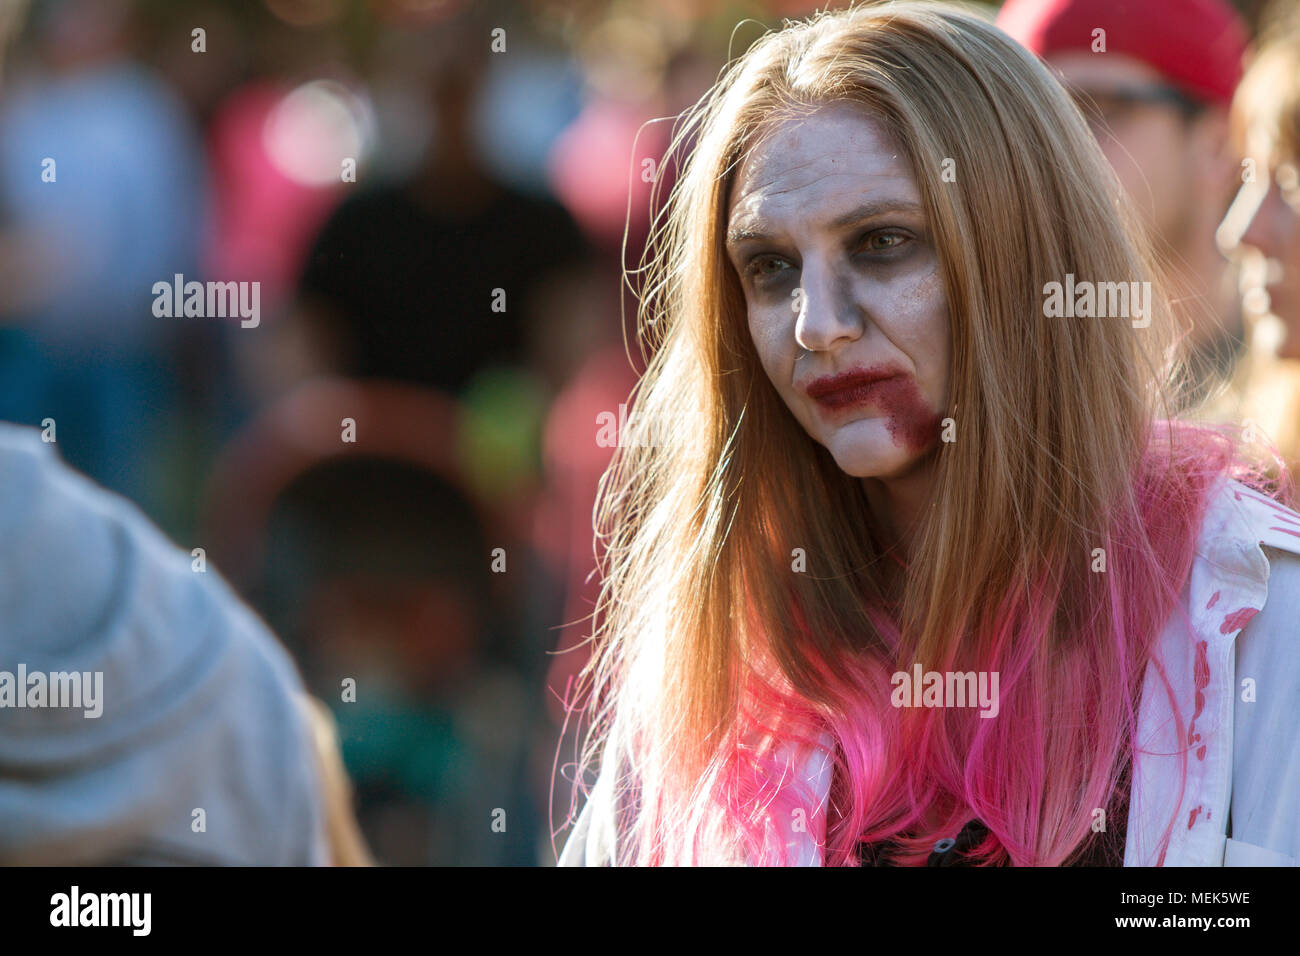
[{"left": 997, "top": 0, "right": 1248, "bottom": 107}]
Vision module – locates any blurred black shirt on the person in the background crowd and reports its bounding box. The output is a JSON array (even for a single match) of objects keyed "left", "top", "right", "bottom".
[{"left": 300, "top": 180, "right": 586, "bottom": 393}]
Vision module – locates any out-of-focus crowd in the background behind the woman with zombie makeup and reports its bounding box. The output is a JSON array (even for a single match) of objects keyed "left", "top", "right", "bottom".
[{"left": 0, "top": 0, "right": 1300, "bottom": 865}]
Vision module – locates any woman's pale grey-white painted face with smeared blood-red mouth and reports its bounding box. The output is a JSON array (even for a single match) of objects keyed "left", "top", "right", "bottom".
[{"left": 727, "top": 103, "right": 950, "bottom": 479}]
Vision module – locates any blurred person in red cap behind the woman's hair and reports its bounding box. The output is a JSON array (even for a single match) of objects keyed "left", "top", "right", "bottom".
[{"left": 996, "top": 0, "right": 1248, "bottom": 399}]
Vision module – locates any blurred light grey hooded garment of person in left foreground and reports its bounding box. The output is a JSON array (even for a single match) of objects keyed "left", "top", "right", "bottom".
[{"left": 0, "top": 424, "right": 364, "bottom": 865}]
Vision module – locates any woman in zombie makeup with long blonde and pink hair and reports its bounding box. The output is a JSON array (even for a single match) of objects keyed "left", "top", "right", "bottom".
[{"left": 560, "top": 4, "right": 1300, "bottom": 865}]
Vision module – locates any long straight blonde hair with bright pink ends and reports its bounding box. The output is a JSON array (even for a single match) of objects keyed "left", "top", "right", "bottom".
[{"left": 564, "top": 3, "right": 1284, "bottom": 865}]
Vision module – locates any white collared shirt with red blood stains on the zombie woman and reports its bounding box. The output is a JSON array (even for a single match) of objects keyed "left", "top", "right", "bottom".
[{"left": 559, "top": 480, "right": 1300, "bottom": 866}]
